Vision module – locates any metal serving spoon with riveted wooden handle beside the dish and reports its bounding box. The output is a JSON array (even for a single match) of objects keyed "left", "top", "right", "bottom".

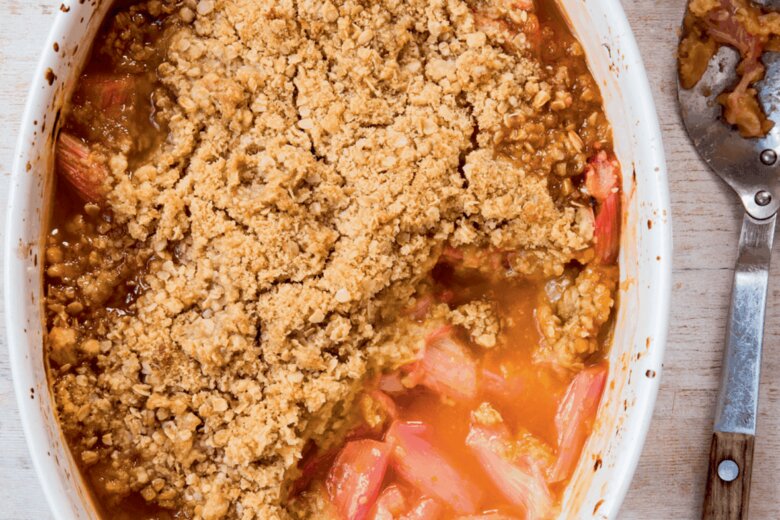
[{"left": 678, "top": 0, "right": 780, "bottom": 520}]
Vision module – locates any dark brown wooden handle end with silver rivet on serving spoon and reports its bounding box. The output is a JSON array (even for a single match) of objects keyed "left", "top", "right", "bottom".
[{"left": 702, "top": 432, "right": 755, "bottom": 520}]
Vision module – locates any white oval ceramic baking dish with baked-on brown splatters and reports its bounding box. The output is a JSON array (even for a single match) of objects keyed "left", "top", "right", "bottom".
[{"left": 4, "top": 0, "right": 672, "bottom": 519}]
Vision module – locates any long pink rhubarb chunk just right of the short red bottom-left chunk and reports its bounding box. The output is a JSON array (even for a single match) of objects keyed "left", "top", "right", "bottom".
[{"left": 386, "top": 421, "right": 480, "bottom": 514}]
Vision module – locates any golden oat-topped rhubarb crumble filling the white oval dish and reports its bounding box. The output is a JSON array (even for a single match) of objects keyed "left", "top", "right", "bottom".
[{"left": 44, "top": 0, "right": 622, "bottom": 519}]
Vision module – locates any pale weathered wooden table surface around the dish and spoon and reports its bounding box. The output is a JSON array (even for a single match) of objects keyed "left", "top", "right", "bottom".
[{"left": 0, "top": 0, "right": 780, "bottom": 520}]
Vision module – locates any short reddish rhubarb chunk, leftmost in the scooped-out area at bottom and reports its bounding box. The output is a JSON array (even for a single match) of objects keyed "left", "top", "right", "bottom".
[{"left": 326, "top": 440, "right": 391, "bottom": 520}]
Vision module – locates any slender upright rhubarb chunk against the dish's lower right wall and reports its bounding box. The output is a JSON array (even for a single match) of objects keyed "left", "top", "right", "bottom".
[{"left": 550, "top": 366, "right": 607, "bottom": 482}]
